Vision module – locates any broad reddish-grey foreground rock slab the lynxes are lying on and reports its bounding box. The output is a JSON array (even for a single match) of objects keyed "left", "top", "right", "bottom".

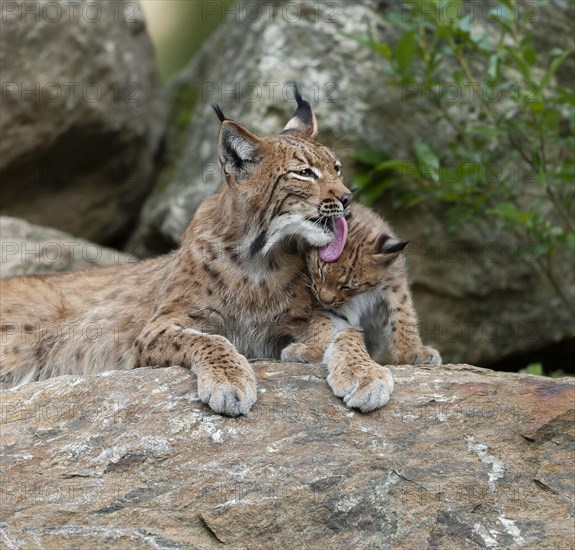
[{"left": 0, "top": 361, "right": 575, "bottom": 550}]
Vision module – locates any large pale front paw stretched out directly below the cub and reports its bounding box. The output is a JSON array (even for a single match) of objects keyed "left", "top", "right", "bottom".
[{"left": 327, "top": 363, "right": 393, "bottom": 413}]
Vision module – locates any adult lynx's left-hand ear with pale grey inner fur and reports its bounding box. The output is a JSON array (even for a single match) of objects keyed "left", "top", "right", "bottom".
[{"left": 218, "top": 118, "right": 263, "bottom": 181}]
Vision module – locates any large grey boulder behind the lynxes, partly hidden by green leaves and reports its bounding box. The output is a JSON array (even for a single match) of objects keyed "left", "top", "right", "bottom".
[{"left": 130, "top": 0, "right": 575, "bottom": 365}]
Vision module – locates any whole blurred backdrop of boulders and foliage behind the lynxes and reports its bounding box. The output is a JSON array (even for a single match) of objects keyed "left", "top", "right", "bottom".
[{"left": 0, "top": 0, "right": 575, "bottom": 376}]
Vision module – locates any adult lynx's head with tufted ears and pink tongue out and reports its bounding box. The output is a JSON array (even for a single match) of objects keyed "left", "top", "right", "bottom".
[{"left": 217, "top": 89, "right": 352, "bottom": 262}]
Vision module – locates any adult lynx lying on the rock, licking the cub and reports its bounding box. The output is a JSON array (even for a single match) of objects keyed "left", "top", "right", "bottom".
[{"left": 0, "top": 90, "right": 351, "bottom": 416}]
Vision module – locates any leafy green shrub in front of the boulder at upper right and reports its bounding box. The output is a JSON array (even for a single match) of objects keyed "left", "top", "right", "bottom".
[{"left": 355, "top": 0, "right": 575, "bottom": 261}]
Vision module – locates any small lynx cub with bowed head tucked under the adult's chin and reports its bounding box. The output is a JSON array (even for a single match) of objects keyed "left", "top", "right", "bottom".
[{"left": 316, "top": 204, "right": 441, "bottom": 364}]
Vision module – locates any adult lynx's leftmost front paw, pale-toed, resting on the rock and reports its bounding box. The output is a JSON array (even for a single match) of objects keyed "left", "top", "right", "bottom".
[{"left": 198, "top": 357, "right": 257, "bottom": 416}]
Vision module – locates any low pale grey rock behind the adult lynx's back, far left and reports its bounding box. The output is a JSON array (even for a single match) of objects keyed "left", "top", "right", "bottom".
[{"left": 0, "top": 216, "right": 136, "bottom": 278}]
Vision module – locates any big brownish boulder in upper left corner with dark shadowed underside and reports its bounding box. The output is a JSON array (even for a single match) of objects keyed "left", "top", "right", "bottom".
[{"left": 0, "top": 0, "right": 165, "bottom": 243}]
